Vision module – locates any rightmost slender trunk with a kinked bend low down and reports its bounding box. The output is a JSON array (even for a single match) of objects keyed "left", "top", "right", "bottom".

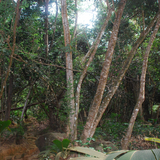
[{"left": 122, "top": 10, "right": 160, "bottom": 149}]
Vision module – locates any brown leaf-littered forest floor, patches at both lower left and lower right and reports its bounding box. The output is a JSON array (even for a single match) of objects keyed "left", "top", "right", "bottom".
[{"left": 0, "top": 117, "right": 159, "bottom": 160}]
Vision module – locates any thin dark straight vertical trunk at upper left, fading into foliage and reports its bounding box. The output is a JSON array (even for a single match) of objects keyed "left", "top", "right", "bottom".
[{"left": 45, "top": 0, "right": 49, "bottom": 57}]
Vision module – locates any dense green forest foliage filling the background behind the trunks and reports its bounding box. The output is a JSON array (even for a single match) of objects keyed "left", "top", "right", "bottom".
[{"left": 0, "top": 0, "right": 160, "bottom": 148}]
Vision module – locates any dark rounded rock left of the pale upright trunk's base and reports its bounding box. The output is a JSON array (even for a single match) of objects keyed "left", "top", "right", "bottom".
[{"left": 35, "top": 132, "right": 66, "bottom": 152}]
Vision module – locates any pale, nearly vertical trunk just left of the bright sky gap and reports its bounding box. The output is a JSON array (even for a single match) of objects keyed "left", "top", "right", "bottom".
[{"left": 61, "top": 0, "right": 76, "bottom": 140}]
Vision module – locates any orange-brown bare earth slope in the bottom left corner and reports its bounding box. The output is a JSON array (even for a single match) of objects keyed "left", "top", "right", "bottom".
[{"left": 0, "top": 117, "right": 49, "bottom": 160}]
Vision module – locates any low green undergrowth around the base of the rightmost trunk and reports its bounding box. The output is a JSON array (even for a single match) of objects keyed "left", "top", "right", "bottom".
[{"left": 78, "top": 119, "right": 160, "bottom": 149}]
